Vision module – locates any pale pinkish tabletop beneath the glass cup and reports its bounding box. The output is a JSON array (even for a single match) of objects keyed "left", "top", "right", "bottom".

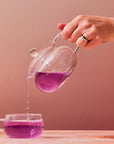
[{"left": 0, "top": 130, "right": 114, "bottom": 144}]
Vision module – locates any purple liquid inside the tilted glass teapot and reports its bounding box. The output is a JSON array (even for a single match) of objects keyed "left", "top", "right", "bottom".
[{"left": 35, "top": 72, "right": 70, "bottom": 93}]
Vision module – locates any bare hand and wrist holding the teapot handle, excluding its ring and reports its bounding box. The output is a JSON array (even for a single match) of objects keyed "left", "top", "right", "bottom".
[{"left": 58, "top": 15, "right": 114, "bottom": 49}]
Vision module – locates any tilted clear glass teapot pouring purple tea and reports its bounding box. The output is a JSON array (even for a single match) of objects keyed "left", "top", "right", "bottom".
[{"left": 27, "top": 33, "right": 79, "bottom": 93}]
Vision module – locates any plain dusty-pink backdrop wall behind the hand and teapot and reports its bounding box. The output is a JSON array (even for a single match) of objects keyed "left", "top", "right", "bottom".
[{"left": 0, "top": 0, "right": 114, "bottom": 129}]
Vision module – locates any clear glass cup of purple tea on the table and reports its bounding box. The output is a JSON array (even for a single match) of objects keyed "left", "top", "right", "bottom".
[{"left": 4, "top": 113, "right": 44, "bottom": 138}]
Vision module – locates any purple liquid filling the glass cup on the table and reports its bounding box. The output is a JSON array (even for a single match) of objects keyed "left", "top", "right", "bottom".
[{"left": 4, "top": 121, "right": 44, "bottom": 138}]
